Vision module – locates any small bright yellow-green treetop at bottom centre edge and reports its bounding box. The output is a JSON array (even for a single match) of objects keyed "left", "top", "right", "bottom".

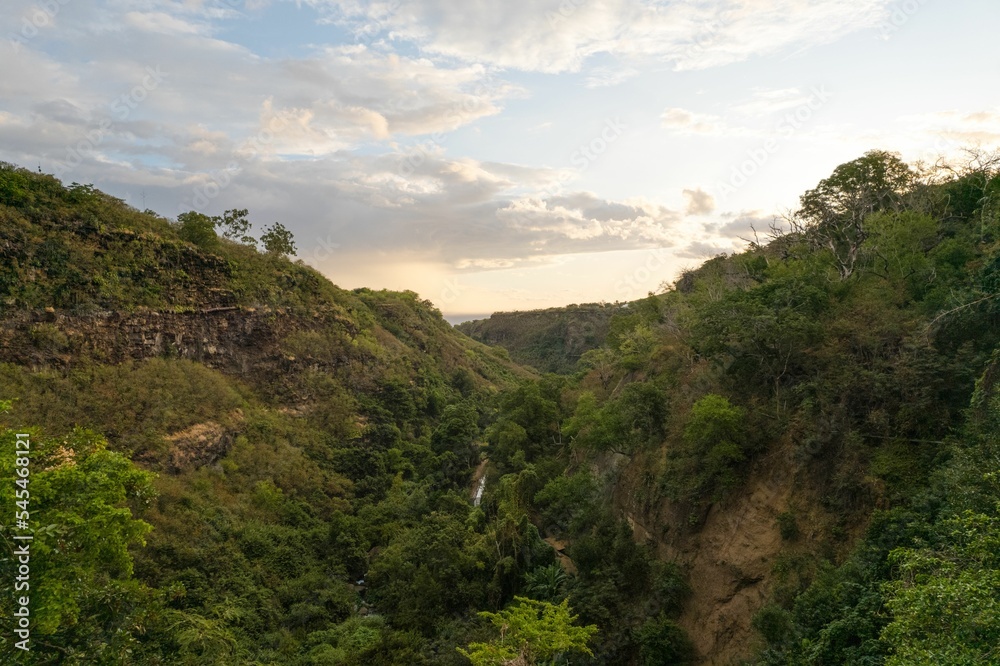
[{"left": 459, "top": 597, "right": 597, "bottom": 666}]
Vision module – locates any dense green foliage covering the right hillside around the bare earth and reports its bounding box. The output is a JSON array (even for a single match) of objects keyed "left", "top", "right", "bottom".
[{"left": 466, "top": 151, "right": 1000, "bottom": 664}]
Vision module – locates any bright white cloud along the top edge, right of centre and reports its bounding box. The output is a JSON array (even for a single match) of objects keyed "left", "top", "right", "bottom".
[{"left": 318, "top": 0, "right": 890, "bottom": 73}]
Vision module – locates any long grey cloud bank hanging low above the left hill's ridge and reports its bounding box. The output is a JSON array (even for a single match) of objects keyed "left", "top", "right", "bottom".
[{"left": 58, "top": 148, "right": 683, "bottom": 274}]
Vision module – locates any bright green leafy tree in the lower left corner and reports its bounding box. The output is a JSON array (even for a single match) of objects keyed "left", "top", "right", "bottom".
[{"left": 0, "top": 420, "right": 159, "bottom": 664}]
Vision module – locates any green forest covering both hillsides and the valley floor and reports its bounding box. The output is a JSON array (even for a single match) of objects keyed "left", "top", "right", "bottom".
[{"left": 0, "top": 150, "right": 1000, "bottom": 666}]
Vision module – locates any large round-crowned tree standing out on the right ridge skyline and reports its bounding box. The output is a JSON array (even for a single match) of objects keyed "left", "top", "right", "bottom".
[{"left": 792, "top": 150, "right": 916, "bottom": 280}]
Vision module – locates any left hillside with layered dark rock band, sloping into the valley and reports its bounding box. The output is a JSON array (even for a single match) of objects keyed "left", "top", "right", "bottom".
[{"left": 0, "top": 160, "right": 533, "bottom": 664}]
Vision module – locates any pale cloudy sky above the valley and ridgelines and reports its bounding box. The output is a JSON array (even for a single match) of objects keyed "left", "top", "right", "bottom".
[{"left": 0, "top": 0, "right": 1000, "bottom": 320}]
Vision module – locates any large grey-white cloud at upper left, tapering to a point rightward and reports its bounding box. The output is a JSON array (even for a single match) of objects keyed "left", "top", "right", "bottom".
[{"left": 0, "top": 8, "right": 522, "bottom": 169}]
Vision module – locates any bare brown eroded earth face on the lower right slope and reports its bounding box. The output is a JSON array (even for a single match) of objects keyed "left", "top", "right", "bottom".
[{"left": 615, "top": 440, "right": 858, "bottom": 666}]
